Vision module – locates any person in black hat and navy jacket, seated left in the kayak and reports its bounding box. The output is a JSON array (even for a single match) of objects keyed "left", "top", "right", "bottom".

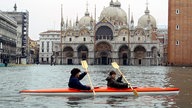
[{"left": 68, "top": 68, "right": 91, "bottom": 90}]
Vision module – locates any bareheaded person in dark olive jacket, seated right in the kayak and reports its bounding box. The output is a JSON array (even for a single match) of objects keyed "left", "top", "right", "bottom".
[{"left": 106, "top": 71, "right": 128, "bottom": 88}]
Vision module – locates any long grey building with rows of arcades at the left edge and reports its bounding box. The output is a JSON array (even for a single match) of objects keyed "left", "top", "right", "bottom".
[{"left": 0, "top": 11, "right": 17, "bottom": 63}]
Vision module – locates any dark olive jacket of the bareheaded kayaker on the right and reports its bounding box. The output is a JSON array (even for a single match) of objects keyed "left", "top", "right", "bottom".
[{"left": 106, "top": 76, "right": 128, "bottom": 88}]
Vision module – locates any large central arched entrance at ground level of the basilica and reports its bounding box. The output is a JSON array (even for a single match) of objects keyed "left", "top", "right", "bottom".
[{"left": 95, "top": 42, "right": 112, "bottom": 65}]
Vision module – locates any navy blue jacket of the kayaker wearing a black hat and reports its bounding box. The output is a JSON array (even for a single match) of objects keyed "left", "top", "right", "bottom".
[{"left": 68, "top": 72, "right": 91, "bottom": 90}]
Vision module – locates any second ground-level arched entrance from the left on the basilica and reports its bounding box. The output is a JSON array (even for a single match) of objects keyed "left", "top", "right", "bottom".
[{"left": 77, "top": 45, "right": 88, "bottom": 60}]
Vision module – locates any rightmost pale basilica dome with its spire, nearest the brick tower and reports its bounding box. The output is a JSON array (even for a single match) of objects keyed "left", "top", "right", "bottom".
[{"left": 138, "top": 7, "right": 156, "bottom": 28}]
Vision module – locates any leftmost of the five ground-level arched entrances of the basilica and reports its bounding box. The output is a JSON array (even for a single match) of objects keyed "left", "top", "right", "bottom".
[{"left": 64, "top": 47, "right": 74, "bottom": 65}]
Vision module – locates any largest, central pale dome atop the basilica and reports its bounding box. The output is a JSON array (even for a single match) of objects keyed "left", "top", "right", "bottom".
[{"left": 100, "top": 0, "right": 127, "bottom": 23}]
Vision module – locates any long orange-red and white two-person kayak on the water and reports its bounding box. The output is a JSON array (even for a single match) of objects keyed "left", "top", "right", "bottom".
[{"left": 20, "top": 87, "right": 179, "bottom": 96}]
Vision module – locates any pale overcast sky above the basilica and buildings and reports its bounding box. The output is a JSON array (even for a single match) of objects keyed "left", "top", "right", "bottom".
[{"left": 0, "top": 0, "right": 168, "bottom": 40}]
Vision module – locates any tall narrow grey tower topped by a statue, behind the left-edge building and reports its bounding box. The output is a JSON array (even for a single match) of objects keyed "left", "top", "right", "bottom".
[{"left": 4, "top": 4, "right": 29, "bottom": 64}]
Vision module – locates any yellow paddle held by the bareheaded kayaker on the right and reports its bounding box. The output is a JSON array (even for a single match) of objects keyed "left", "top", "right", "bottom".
[{"left": 111, "top": 62, "right": 138, "bottom": 96}]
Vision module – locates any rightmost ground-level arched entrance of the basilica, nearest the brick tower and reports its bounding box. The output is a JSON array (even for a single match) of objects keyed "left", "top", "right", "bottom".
[{"left": 134, "top": 46, "right": 146, "bottom": 65}]
